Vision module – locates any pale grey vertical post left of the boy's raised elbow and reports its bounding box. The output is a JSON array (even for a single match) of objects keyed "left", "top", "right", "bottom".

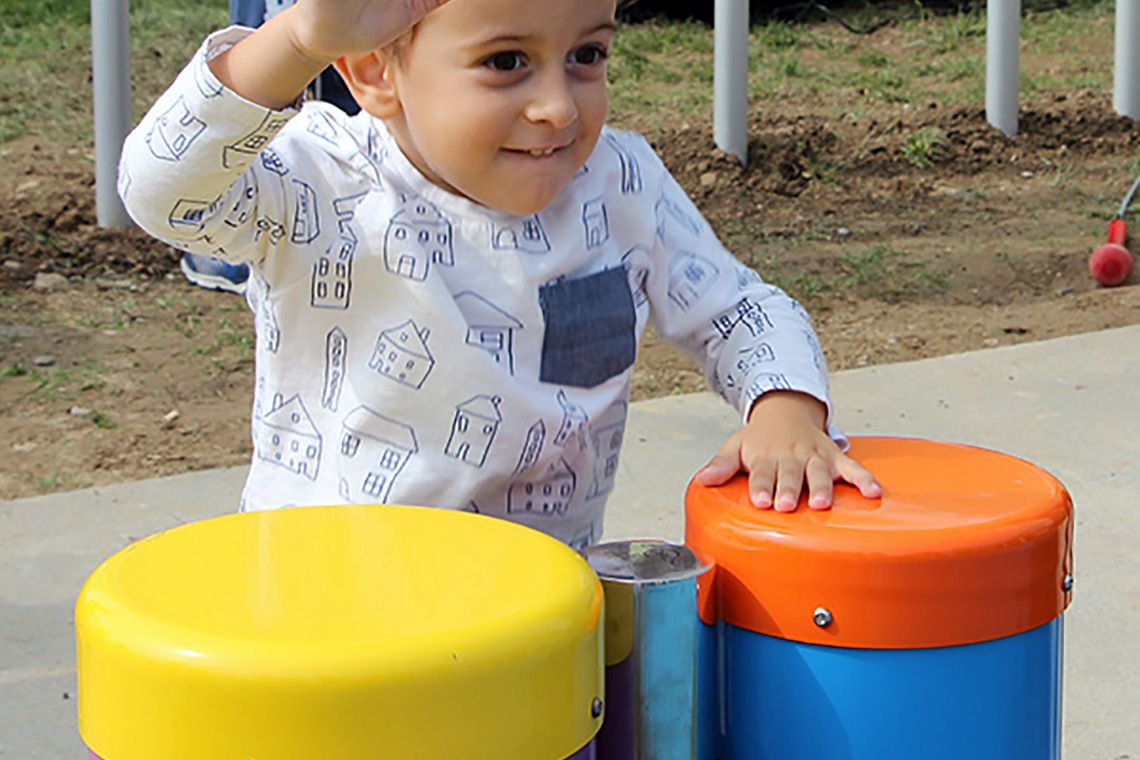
[{"left": 91, "top": 0, "right": 131, "bottom": 227}]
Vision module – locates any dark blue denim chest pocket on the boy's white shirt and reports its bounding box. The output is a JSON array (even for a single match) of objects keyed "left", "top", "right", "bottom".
[{"left": 538, "top": 267, "right": 637, "bottom": 387}]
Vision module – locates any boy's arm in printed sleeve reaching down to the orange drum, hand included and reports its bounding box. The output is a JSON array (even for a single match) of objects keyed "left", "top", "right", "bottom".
[{"left": 629, "top": 133, "right": 880, "bottom": 512}]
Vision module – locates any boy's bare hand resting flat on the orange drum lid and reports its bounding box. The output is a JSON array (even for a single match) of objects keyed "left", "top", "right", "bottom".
[{"left": 697, "top": 391, "right": 882, "bottom": 512}]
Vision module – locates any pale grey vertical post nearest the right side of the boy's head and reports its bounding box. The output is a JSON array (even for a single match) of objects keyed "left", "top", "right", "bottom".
[{"left": 713, "top": 0, "right": 748, "bottom": 164}]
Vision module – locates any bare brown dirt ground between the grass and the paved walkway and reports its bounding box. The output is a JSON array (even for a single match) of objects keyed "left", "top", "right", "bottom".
[{"left": 0, "top": 82, "right": 1140, "bottom": 498}]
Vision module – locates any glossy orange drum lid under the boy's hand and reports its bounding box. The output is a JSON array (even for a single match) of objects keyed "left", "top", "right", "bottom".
[{"left": 685, "top": 438, "right": 1073, "bottom": 648}]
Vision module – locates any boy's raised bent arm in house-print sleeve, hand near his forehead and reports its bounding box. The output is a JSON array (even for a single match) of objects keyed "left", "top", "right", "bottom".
[{"left": 119, "top": 0, "right": 446, "bottom": 262}]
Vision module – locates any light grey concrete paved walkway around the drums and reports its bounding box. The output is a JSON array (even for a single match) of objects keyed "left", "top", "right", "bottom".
[{"left": 0, "top": 326, "right": 1140, "bottom": 760}]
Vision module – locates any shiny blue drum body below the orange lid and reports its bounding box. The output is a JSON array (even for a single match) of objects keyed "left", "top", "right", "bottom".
[{"left": 699, "top": 618, "right": 1064, "bottom": 760}]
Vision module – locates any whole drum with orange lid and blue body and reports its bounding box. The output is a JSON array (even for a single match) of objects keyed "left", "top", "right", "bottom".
[{"left": 686, "top": 438, "right": 1073, "bottom": 760}]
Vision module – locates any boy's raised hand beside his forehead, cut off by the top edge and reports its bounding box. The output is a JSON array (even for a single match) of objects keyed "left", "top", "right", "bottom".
[{"left": 288, "top": 0, "right": 448, "bottom": 64}]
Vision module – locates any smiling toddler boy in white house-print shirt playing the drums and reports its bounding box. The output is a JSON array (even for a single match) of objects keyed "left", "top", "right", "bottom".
[{"left": 120, "top": 0, "right": 878, "bottom": 546}]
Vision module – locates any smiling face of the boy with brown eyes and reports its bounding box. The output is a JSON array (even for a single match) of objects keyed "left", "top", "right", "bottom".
[{"left": 388, "top": 0, "right": 614, "bottom": 215}]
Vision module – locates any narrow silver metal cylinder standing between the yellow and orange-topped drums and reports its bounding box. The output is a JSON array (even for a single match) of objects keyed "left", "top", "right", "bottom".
[{"left": 584, "top": 540, "right": 709, "bottom": 760}]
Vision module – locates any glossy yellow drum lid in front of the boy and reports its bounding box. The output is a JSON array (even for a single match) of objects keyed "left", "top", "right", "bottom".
[{"left": 75, "top": 506, "right": 603, "bottom": 760}]
